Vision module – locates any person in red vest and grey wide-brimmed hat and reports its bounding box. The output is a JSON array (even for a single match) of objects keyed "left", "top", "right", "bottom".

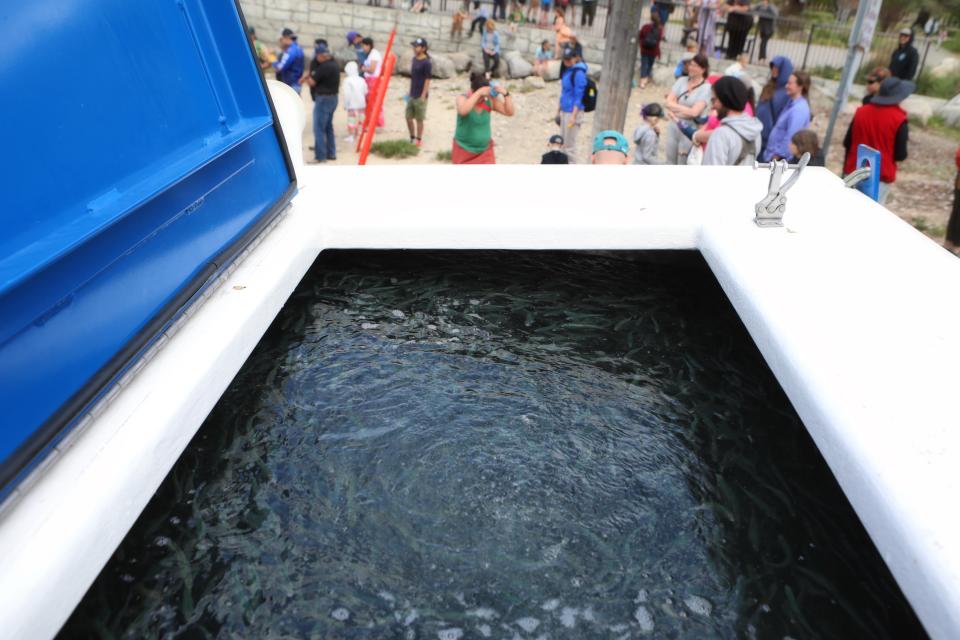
[{"left": 843, "top": 78, "right": 916, "bottom": 204}]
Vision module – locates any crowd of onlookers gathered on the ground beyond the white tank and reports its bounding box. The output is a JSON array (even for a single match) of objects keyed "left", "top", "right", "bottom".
[{"left": 251, "top": 5, "right": 944, "bottom": 212}]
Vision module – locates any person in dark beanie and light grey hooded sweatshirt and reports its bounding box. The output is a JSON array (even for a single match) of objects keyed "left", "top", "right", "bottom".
[{"left": 703, "top": 76, "right": 763, "bottom": 166}]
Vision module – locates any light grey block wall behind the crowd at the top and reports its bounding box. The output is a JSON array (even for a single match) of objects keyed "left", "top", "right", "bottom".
[{"left": 240, "top": 0, "right": 604, "bottom": 64}]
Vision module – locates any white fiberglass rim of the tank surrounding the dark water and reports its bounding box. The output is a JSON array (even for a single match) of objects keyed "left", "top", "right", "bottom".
[{"left": 0, "top": 85, "right": 960, "bottom": 638}]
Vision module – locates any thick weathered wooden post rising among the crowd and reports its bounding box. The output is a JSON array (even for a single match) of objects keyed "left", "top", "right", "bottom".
[{"left": 593, "top": 0, "right": 644, "bottom": 135}]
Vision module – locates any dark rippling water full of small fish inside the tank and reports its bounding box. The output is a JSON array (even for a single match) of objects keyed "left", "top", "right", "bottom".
[{"left": 62, "top": 252, "right": 923, "bottom": 640}]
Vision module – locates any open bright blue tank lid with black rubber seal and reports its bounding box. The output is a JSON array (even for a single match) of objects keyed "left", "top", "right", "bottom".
[{"left": 0, "top": 0, "right": 295, "bottom": 497}]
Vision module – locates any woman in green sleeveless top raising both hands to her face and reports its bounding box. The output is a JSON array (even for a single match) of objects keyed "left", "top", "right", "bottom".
[{"left": 451, "top": 71, "right": 513, "bottom": 164}]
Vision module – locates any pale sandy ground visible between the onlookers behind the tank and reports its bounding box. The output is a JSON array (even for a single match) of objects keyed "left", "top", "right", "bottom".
[{"left": 303, "top": 69, "right": 960, "bottom": 239}]
